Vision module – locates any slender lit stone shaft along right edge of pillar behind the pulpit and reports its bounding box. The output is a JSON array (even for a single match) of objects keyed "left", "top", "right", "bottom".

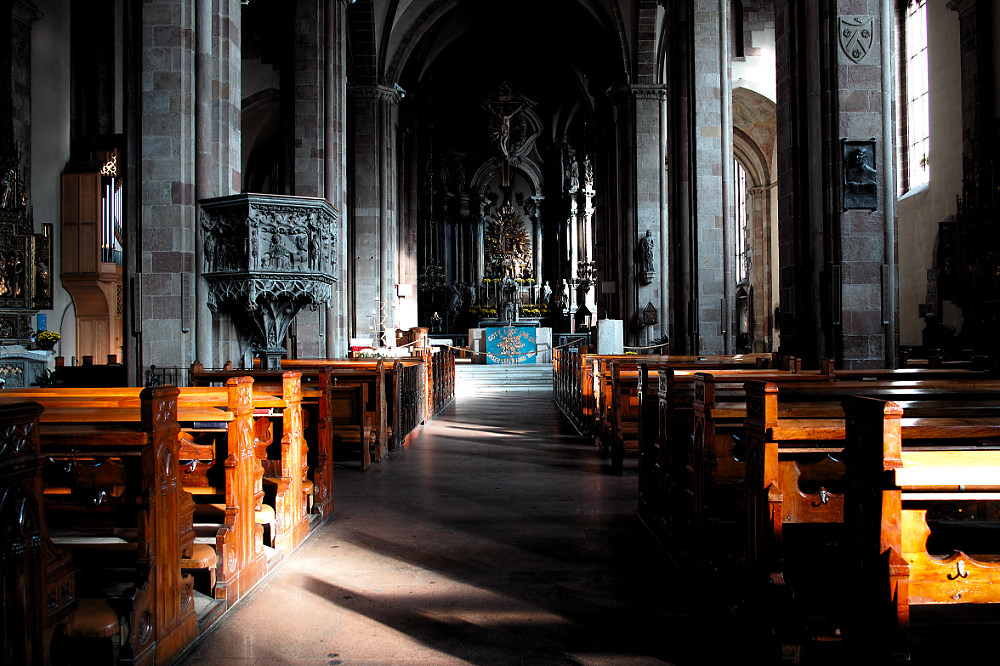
[{"left": 323, "top": 0, "right": 349, "bottom": 358}]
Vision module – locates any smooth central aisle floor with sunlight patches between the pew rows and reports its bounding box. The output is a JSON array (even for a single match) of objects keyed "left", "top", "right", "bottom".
[{"left": 183, "top": 390, "right": 744, "bottom": 664}]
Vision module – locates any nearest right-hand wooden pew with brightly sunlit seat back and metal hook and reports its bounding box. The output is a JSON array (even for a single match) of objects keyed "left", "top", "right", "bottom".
[{"left": 844, "top": 397, "right": 1000, "bottom": 655}]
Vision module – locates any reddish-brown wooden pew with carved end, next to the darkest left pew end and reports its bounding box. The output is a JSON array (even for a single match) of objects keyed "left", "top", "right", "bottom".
[{"left": 0, "top": 387, "right": 198, "bottom": 664}]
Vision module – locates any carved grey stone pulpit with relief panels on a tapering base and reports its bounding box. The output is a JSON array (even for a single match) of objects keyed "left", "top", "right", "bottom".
[{"left": 201, "top": 194, "right": 338, "bottom": 368}]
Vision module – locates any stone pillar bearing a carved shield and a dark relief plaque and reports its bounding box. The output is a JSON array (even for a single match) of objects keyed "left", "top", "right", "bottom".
[{"left": 775, "top": 0, "right": 896, "bottom": 368}]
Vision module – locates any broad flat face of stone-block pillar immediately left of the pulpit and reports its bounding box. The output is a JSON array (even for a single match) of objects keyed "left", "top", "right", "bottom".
[{"left": 137, "top": 0, "right": 197, "bottom": 367}]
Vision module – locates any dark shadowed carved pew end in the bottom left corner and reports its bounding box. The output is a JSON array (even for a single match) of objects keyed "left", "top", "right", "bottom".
[{"left": 0, "top": 402, "right": 76, "bottom": 664}]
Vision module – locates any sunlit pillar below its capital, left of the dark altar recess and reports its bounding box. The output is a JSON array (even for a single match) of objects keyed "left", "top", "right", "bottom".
[{"left": 348, "top": 86, "right": 399, "bottom": 337}]
